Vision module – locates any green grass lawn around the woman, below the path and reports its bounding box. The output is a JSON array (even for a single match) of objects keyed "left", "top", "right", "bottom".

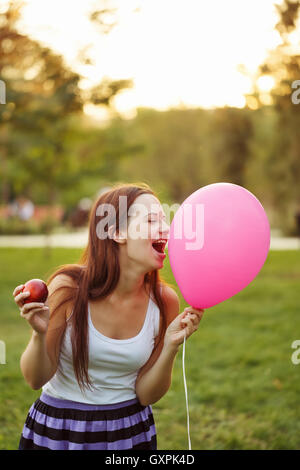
[{"left": 0, "top": 248, "right": 300, "bottom": 449}]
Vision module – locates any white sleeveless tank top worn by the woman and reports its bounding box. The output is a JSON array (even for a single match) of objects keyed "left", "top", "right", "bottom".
[{"left": 42, "top": 290, "right": 159, "bottom": 405}]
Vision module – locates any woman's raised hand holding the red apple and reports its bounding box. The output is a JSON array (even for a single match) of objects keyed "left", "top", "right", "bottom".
[{"left": 13, "top": 284, "right": 50, "bottom": 335}]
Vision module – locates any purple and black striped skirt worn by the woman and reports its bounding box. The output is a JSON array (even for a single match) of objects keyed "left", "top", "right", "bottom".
[{"left": 19, "top": 392, "right": 157, "bottom": 450}]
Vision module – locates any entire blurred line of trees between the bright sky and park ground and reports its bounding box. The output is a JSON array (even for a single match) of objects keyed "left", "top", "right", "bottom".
[{"left": 0, "top": 0, "right": 300, "bottom": 235}]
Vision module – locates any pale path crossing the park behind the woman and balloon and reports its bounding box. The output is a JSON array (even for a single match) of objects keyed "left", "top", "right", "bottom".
[{"left": 0, "top": 230, "right": 300, "bottom": 250}]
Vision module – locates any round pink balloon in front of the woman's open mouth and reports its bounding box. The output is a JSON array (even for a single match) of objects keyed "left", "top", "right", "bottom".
[{"left": 168, "top": 183, "right": 270, "bottom": 308}]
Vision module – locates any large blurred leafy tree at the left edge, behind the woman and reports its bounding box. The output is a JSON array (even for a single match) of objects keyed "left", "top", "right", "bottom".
[{"left": 0, "top": 1, "right": 131, "bottom": 205}]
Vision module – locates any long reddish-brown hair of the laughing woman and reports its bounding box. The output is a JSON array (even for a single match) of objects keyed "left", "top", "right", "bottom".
[{"left": 47, "top": 183, "right": 171, "bottom": 389}]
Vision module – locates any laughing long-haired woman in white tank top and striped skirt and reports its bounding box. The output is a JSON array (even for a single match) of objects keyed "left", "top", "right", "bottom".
[{"left": 13, "top": 184, "right": 203, "bottom": 450}]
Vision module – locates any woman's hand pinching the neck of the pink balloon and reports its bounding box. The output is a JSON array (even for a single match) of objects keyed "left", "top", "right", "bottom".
[{"left": 164, "top": 307, "right": 204, "bottom": 347}]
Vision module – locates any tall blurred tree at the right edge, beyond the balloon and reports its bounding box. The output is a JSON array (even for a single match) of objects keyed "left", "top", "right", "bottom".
[{"left": 248, "top": 0, "right": 300, "bottom": 233}]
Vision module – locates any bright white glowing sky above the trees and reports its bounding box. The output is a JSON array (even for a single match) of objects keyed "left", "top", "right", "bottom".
[{"left": 16, "top": 0, "right": 281, "bottom": 118}]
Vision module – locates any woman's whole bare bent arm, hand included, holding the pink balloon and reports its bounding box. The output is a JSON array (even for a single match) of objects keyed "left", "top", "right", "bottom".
[{"left": 136, "top": 287, "right": 204, "bottom": 406}]
